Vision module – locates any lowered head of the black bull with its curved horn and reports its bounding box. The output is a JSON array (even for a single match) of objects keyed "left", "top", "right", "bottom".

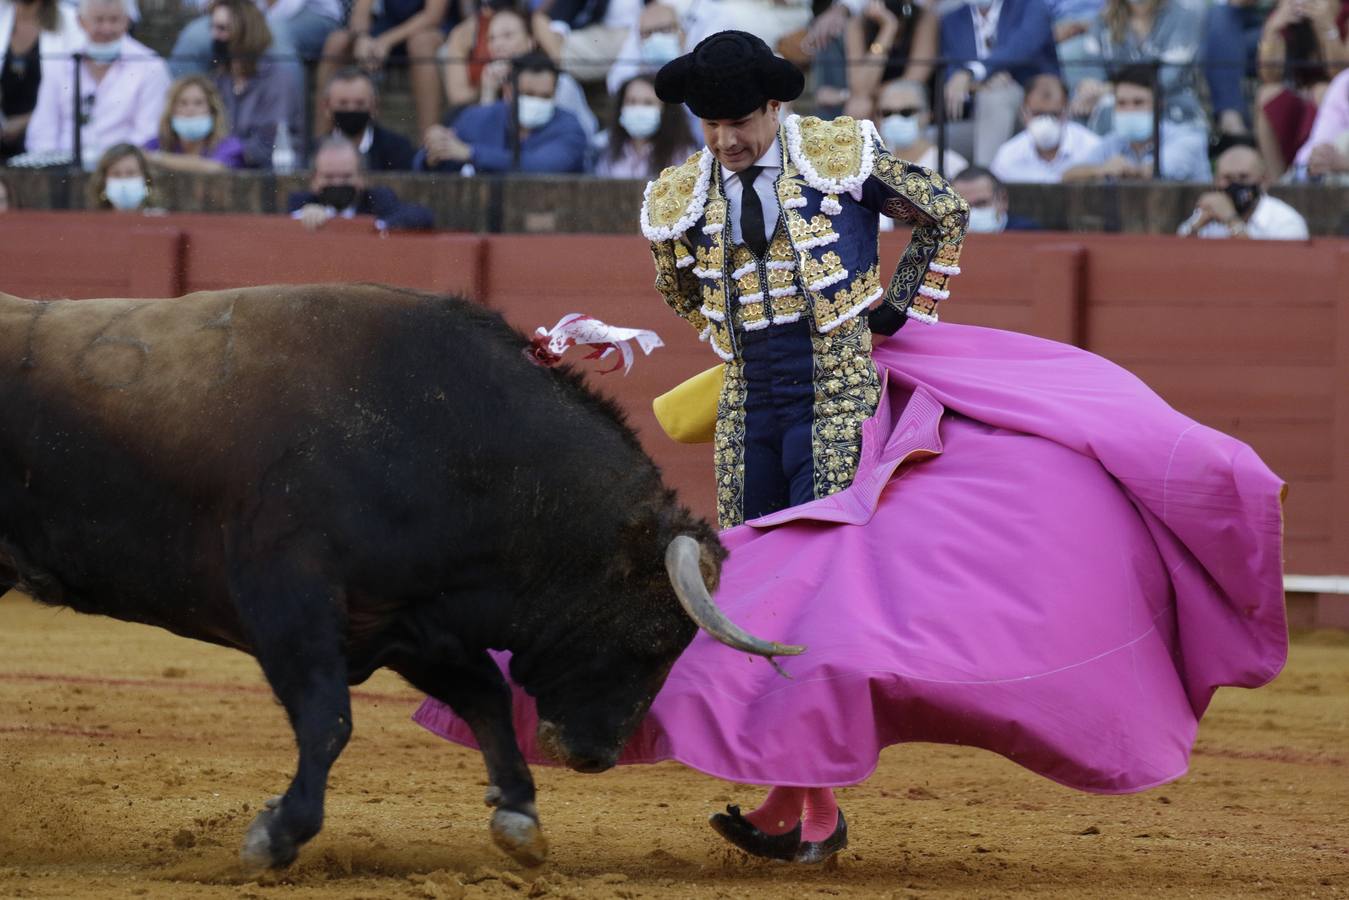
[{"left": 523, "top": 533, "right": 805, "bottom": 772}]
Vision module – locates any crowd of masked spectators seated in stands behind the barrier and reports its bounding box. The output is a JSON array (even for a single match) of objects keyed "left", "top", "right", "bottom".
[{"left": 0, "top": 0, "right": 1349, "bottom": 236}]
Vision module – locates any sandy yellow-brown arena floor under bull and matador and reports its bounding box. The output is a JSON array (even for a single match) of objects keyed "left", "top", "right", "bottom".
[{"left": 0, "top": 595, "right": 1349, "bottom": 900}]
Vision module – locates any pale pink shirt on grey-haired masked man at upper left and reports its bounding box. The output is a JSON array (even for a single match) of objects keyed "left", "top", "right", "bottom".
[{"left": 27, "top": 35, "right": 170, "bottom": 167}]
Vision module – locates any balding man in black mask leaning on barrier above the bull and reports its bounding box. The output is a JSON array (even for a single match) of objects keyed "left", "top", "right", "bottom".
[{"left": 286, "top": 135, "right": 434, "bottom": 231}]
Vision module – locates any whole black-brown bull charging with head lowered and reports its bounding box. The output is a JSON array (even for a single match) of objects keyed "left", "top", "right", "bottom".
[{"left": 0, "top": 285, "right": 799, "bottom": 866}]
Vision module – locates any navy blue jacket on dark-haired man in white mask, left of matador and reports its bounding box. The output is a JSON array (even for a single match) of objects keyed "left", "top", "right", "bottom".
[{"left": 415, "top": 100, "right": 587, "bottom": 173}]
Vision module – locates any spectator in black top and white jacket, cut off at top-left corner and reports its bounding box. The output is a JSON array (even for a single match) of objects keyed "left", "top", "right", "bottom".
[{"left": 0, "top": 0, "right": 85, "bottom": 161}]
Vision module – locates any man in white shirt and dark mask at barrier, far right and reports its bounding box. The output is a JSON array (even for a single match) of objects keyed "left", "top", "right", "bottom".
[{"left": 1176, "top": 146, "right": 1309, "bottom": 240}]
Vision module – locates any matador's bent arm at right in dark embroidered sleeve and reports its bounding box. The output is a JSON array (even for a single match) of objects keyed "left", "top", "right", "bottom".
[{"left": 861, "top": 144, "right": 970, "bottom": 335}]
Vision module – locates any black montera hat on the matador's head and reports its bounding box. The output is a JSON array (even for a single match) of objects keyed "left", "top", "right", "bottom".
[{"left": 656, "top": 31, "right": 805, "bottom": 119}]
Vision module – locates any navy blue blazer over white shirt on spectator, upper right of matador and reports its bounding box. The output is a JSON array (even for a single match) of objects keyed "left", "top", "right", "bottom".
[{"left": 942, "top": 0, "right": 1059, "bottom": 86}]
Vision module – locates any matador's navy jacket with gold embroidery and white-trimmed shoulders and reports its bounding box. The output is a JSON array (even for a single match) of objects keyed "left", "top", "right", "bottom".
[{"left": 642, "top": 116, "right": 969, "bottom": 359}]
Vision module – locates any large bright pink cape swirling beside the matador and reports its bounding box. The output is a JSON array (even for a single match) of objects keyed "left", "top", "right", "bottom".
[{"left": 414, "top": 324, "right": 1287, "bottom": 793}]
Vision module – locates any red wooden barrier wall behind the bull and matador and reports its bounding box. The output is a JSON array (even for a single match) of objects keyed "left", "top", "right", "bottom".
[{"left": 0, "top": 213, "right": 1349, "bottom": 573}]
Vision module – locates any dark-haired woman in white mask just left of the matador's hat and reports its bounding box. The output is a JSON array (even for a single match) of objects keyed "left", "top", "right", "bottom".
[{"left": 595, "top": 76, "right": 697, "bottom": 181}]
